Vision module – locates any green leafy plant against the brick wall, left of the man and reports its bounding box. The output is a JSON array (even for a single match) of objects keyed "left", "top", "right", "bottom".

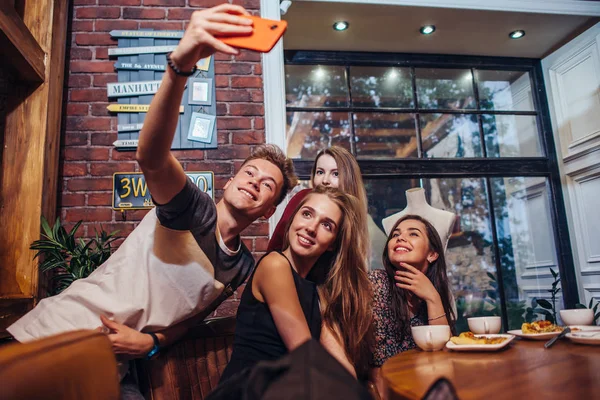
[{"left": 30, "top": 217, "right": 118, "bottom": 295}]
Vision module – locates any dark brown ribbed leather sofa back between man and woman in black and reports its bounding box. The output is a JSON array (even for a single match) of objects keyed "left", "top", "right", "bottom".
[{"left": 137, "top": 317, "right": 235, "bottom": 400}]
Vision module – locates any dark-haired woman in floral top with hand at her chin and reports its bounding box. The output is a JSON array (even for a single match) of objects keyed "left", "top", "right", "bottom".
[{"left": 369, "top": 215, "right": 456, "bottom": 393}]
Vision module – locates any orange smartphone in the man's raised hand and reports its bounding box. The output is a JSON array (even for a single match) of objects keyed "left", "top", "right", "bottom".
[{"left": 218, "top": 15, "right": 287, "bottom": 53}]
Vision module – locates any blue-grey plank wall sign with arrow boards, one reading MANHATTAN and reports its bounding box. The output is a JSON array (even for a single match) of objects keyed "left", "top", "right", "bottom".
[{"left": 107, "top": 30, "right": 217, "bottom": 151}]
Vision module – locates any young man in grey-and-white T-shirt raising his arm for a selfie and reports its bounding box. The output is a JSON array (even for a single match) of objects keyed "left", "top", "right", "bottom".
[{"left": 8, "top": 4, "right": 297, "bottom": 394}]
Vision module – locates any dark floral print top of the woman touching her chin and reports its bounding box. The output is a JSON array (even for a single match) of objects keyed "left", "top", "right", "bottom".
[{"left": 369, "top": 269, "right": 427, "bottom": 367}]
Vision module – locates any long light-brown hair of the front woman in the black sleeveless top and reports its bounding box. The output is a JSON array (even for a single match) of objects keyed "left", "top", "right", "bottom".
[{"left": 283, "top": 186, "right": 373, "bottom": 378}]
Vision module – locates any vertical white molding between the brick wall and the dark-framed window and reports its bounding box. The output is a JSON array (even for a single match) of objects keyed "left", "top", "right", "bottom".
[{"left": 260, "top": 0, "right": 287, "bottom": 237}]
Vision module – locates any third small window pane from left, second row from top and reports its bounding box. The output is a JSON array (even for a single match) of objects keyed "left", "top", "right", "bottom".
[{"left": 420, "top": 114, "right": 483, "bottom": 158}]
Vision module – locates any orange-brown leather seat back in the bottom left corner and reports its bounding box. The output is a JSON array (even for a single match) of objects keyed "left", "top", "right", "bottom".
[{"left": 0, "top": 331, "right": 119, "bottom": 400}]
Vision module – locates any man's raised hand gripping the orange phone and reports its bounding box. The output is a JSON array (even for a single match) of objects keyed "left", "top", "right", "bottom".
[{"left": 171, "top": 4, "right": 252, "bottom": 71}]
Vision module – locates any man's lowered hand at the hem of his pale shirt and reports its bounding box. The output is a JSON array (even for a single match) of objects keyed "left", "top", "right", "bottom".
[{"left": 100, "top": 315, "right": 154, "bottom": 359}]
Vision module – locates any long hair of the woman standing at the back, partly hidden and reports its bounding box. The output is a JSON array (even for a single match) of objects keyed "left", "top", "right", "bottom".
[{"left": 310, "top": 146, "right": 371, "bottom": 267}]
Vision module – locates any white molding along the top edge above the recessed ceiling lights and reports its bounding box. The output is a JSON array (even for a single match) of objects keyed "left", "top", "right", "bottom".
[{"left": 294, "top": 0, "right": 600, "bottom": 16}]
